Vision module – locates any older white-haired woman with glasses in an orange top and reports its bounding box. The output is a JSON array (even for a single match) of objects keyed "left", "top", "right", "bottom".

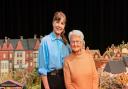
[{"left": 64, "top": 30, "right": 98, "bottom": 89}]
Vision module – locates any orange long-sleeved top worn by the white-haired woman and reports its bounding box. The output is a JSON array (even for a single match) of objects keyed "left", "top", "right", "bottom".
[{"left": 64, "top": 51, "right": 98, "bottom": 89}]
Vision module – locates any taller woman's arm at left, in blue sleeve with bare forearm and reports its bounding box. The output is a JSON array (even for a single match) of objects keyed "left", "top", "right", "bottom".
[{"left": 38, "top": 39, "right": 50, "bottom": 89}]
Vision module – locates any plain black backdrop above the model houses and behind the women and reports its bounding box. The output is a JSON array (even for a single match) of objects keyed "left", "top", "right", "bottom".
[{"left": 0, "top": 0, "right": 128, "bottom": 53}]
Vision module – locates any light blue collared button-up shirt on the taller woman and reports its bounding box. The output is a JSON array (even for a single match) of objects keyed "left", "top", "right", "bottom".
[{"left": 38, "top": 32, "right": 70, "bottom": 75}]
